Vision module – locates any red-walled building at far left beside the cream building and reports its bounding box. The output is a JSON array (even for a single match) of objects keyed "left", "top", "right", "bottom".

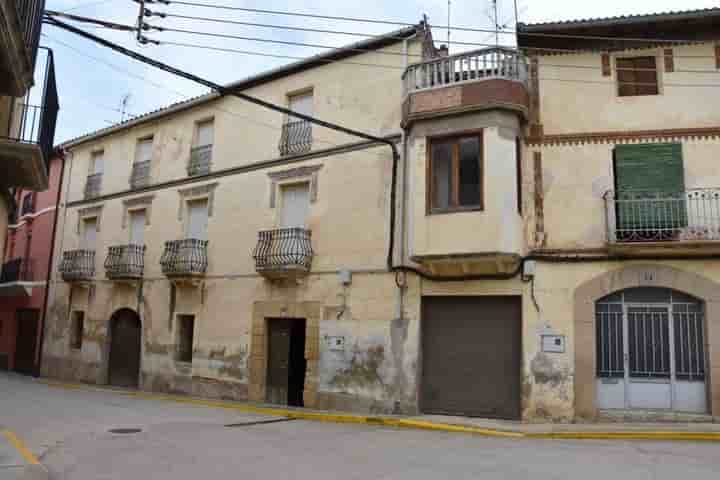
[{"left": 0, "top": 156, "right": 63, "bottom": 375}]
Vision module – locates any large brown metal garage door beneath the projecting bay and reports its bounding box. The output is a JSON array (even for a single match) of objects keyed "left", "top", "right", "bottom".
[{"left": 421, "top": 297, "right": 521, "bottom": 419}]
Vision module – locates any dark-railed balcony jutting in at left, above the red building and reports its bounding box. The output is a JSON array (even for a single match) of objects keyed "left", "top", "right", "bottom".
[{"left": 0, "top": 49, "right": 59, "bottom": 190}]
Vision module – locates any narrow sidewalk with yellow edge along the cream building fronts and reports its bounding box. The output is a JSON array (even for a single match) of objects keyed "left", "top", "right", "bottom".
[{"left": 40, "top": 379, "right": 720, "bottom": 442}]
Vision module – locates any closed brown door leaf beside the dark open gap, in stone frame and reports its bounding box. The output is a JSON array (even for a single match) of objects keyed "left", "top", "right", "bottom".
[{"left": 267, "top": 319, "right": 292, "bottom": 405}]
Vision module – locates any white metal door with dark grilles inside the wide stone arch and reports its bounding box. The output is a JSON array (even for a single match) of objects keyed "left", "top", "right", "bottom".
[{"left": 595, "top": 287, "right": 707, "bottom": 413}]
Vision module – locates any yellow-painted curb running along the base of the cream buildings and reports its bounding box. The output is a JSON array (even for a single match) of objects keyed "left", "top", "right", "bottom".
[{"left": 39, "top": 380, "right": 720, "bottom": 442}]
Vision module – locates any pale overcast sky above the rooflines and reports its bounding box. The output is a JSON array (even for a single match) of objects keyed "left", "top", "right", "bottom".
[{"left": 41, "top": 0, "right": 720, "bottom": 143}]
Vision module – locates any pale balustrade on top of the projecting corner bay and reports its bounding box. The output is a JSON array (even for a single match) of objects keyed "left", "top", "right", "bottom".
[{"left": 403, "top": 47, "right": 528, "bottom": 94}]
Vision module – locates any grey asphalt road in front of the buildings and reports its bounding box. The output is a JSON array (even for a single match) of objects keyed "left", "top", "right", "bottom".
[{"left": 0, "top": 374, "right": 720, "bottom": 480}]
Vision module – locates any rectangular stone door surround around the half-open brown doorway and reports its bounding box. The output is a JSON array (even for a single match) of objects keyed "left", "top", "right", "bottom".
[{"left": 248, "top": 301, "right": 322, "bottom": 408}]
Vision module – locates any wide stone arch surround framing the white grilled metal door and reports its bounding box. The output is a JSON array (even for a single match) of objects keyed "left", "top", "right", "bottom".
[{"left": 573, "top": 264, "right": 720, "bottom": 420}]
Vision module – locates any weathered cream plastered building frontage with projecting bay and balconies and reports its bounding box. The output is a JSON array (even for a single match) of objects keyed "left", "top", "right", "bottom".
[{"left": 43, "top": 10, "right": 720, "bottom": 421}]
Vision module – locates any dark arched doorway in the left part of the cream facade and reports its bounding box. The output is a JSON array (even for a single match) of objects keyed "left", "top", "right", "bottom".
[{"left": 108, "top": 308, "right": 141, "bottom": 388}]
